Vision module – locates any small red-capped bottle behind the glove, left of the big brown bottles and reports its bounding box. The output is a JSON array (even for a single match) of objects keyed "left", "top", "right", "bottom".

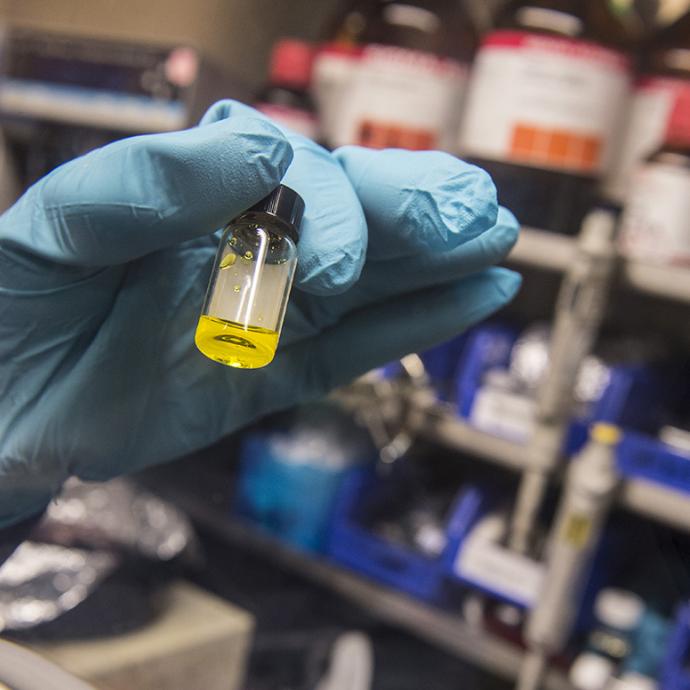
[{"left": 255, "top": 38, "right": 318, "bottom": 139}]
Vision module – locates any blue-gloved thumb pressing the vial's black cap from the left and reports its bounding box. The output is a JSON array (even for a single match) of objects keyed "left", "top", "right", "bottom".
[{"left": 0, "top": 109, "right": 292, "bottom": 267}]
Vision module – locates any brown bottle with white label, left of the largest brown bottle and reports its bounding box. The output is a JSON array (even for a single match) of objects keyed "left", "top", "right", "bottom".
[{"left": 316, "top": 0, "right": 475, "bottom": 150}]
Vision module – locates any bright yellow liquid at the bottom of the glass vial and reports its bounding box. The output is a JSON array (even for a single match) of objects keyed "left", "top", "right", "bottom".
[{"left": 194, "top": 316, "right": 278, "bottom": 369}]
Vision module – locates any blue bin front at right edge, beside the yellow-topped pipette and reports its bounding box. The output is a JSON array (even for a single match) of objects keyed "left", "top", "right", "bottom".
[{"left": 617, "top": 432, "right": 690, "bottom": 493}]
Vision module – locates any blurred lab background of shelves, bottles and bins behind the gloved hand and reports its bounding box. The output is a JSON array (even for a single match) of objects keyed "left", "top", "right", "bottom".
[{"left": 0, "top": 0, "right": 690, "bottom": 690}]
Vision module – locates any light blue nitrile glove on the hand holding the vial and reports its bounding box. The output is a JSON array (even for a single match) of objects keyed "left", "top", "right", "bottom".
[{"left": 0, "top": 102, "right": 519, "bottom": 526}]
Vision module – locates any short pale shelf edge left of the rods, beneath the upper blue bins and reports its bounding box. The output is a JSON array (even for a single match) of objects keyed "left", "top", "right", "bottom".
[{"left": 414, "top": 405, "right": 525, "bottom": 471}]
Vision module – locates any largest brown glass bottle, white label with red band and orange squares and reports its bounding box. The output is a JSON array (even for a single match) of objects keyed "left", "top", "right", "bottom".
[{"left": 459, "top": 0, "right": 630, "bottom": 234}]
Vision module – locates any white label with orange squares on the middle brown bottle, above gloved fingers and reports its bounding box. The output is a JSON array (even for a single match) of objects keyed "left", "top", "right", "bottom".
[{"left": 334, "top": 44, "right": 467, "bottom": 150}]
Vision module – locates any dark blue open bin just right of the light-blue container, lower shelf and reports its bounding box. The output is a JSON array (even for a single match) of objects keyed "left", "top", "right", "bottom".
[{"left": 327, "top": 471, "right": 481, "bottom": 603}]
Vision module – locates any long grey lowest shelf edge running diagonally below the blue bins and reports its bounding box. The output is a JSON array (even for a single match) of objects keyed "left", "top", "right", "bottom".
[{"left": 164, "top": 478, "right": 572, "bottom": 690}]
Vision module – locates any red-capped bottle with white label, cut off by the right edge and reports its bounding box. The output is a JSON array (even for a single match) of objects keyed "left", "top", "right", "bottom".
[{"left": 618, "top": 89, "right": 690, "bottom": 266}]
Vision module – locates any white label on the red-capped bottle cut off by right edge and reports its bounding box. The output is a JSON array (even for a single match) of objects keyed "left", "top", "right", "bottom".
[{"left": 619, "top": 163, "right": 690, "bottom": 266}]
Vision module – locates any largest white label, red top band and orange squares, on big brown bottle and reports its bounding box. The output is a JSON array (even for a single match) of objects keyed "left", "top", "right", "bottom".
[{"left": 459, "top": 31, "right": 629, "bottom": 175}]
